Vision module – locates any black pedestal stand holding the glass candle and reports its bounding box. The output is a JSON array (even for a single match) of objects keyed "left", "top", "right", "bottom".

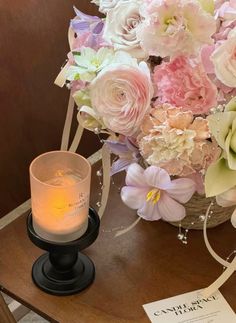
[{"left": 27, "top": 208, "right": 100, "bottom": 295}]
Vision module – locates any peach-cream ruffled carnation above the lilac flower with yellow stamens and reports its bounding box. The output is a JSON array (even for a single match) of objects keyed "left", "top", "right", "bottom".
[{"left": 138, "top": 104, "right": 215, "bottom": 176}]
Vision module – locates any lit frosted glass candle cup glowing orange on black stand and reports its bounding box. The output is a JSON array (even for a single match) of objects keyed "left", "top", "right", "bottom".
[{"left": 30, "top": 151, "right": 91, "bottom": 242}]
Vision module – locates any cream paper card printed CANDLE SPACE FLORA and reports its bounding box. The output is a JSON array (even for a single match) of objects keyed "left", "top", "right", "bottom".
[{"left": 143, "top": 289, "right": 236, "bottom": 323}]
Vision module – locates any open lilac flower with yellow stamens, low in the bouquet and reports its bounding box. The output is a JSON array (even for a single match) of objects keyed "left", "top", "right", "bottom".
[{"left": 121, "top": 163, "right": 195, "bottom": 221}]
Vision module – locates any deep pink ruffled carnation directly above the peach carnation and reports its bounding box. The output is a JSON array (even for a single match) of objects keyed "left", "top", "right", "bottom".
[{"left": 154, "top": 56, "right": 217, "bottom": 114}]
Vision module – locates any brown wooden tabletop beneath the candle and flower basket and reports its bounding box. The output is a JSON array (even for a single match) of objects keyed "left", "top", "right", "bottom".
[{"left": 0, "top": 166, "right": 236, "bottom": 323}]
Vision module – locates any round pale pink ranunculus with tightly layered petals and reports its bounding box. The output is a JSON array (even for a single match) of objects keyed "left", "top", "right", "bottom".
[{"left": 90, "top": 62, "right": 153, "bottom": 136}]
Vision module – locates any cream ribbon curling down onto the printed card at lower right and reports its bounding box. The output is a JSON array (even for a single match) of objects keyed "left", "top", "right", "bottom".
[{"left": 203, "top": 204, "right": 236, "bottom": 298}]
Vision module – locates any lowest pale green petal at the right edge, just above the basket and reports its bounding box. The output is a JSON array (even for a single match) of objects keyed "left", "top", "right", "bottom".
[{"left": 205, "top": 158, "right": 236, "bottom": 197}]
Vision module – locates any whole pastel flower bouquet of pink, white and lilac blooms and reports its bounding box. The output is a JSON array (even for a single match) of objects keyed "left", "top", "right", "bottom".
[{"left": 56, "top": 0, "right": 236, "bottom": 233}]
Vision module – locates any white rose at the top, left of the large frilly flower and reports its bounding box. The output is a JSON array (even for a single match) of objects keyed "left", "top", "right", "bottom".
[{"left": 104, "top": 0, "right": 147, "bottom": 59}]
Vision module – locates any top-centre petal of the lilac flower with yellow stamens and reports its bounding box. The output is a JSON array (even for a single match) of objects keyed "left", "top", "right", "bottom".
[{"left": 144, "top": 166, "right": 171, "bottom": 190}]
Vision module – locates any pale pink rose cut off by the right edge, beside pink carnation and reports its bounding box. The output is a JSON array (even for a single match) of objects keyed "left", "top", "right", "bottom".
[{"left": 211, "top": 27, "right": 236, "bottom": 87}]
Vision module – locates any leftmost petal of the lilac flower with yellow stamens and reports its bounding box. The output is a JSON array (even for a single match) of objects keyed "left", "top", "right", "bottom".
[{"left": 121, "top": 186, "right": 148, "bottom": 210}]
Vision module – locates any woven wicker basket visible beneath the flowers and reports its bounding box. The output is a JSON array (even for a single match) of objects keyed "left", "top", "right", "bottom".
[{"left": 169, "top": 194, "right": 235, "bottom": 230}]
